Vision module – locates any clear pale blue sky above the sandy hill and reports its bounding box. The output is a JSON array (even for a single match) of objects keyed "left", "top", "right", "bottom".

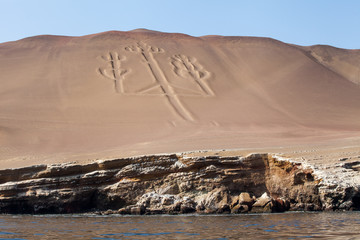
[{"left": 0, "top": 0, "right": 360, "bottom": 49}]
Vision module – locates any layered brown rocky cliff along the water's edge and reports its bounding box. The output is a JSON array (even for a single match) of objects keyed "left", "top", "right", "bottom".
[{"left": 0, "top": 154, "right": 360, "bottom": 214}]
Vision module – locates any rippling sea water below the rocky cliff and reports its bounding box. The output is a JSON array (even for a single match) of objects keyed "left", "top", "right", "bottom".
[{"left": 0, "top": 212, "right": 360, "bottom": 240}]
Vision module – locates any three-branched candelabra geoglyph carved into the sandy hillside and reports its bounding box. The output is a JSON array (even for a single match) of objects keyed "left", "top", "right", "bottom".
[{"left": 98, "top": 42, "right": 214, "bottom": 121}]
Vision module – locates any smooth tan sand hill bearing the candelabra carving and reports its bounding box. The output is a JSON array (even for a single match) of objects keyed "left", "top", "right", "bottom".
[{"left": 0, "top": 29, "right": 360, "bottom": 168}]
